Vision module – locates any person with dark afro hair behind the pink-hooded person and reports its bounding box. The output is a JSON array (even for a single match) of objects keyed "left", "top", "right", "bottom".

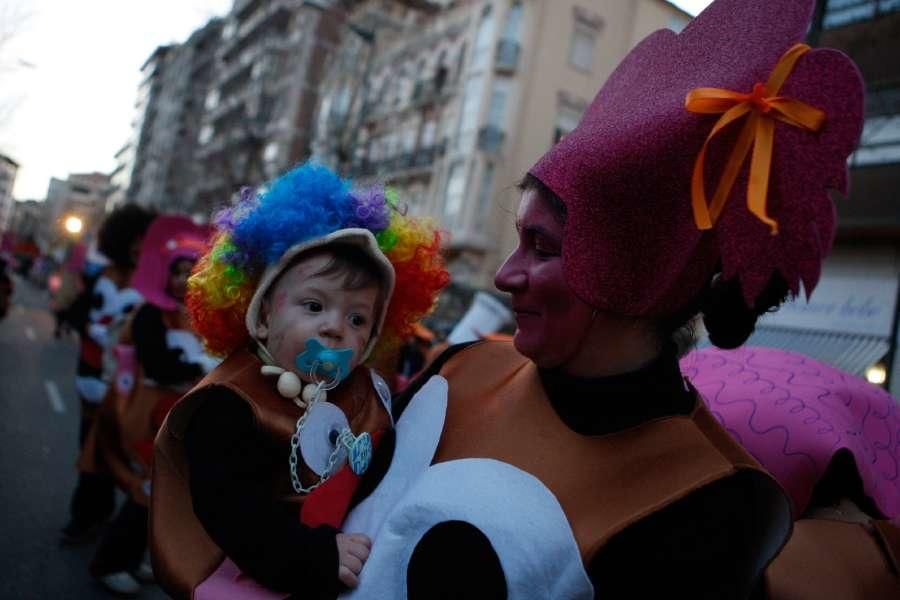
[{"left": 62, "top": 204, "right": 154, "bottom": 543}]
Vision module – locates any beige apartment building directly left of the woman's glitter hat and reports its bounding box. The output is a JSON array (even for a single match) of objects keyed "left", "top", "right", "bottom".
[{"left": 314, "top": 0, "right": 690, "bottom": 286}]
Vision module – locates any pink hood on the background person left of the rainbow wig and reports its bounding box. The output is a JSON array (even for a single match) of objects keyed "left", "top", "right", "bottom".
[{"left": 131, "top": 215, "right": 212, "bottom": 310}]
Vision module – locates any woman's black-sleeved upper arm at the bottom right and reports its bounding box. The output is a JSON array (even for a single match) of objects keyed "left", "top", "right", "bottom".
[{"left": 588, "top": 471, "right": 790, "bottom": 599}]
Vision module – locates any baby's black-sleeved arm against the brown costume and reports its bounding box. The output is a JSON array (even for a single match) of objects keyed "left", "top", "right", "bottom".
[{"left": 185, "top": 388, "right": 341, "bottom": 598}]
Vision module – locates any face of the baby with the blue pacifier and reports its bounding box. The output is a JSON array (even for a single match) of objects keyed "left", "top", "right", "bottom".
[{"left": 257, "top": 253, "right": 379, "bottom": 381}]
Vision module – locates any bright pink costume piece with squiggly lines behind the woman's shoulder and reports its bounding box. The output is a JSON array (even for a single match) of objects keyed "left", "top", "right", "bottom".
[{"left": 681, "top": 347, "right": 900, "bottom": 519}]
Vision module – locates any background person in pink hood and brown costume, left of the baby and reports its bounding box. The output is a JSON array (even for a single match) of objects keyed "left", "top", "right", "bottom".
[{"left": 84, "top": 215, "right": 219, "bottom": 595}]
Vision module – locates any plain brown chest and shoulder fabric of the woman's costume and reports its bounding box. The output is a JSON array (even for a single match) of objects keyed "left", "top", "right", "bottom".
[{"left": 434, "top": 342, "right": 789, "bottom": 564}]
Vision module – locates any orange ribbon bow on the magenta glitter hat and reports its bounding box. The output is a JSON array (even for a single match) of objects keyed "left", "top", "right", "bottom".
[{"left": 684, "top": 44, "right": 825, "bottom": 235}]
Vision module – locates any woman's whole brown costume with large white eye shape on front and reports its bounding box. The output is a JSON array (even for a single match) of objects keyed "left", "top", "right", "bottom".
[{"left": 347, "top": 342, "right": 790, "bottom": 598}]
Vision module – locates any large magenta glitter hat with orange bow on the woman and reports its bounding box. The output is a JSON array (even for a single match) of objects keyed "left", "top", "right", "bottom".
[{"left": 531, "top": 0, "right": 863, "bottom": 316}]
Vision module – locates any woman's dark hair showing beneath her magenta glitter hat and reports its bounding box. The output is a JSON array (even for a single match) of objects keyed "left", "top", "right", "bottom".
[{"left": 518, "top": 173, "right": 790, "bottom": 351}]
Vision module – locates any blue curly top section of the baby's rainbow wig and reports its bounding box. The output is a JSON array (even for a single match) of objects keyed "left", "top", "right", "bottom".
[{"left": 232, "top": 163, "right": 355, "bottom": 265}]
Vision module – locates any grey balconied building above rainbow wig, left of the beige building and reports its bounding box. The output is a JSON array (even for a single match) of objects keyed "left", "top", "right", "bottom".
[{"left": 194, "top": 0, "right": 339, "bottom": 210}]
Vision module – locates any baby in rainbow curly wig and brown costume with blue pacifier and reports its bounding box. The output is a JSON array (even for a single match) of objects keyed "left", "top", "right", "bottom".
[{"left": 151, "top": 164, "right": 449, "bottom": 598}]
